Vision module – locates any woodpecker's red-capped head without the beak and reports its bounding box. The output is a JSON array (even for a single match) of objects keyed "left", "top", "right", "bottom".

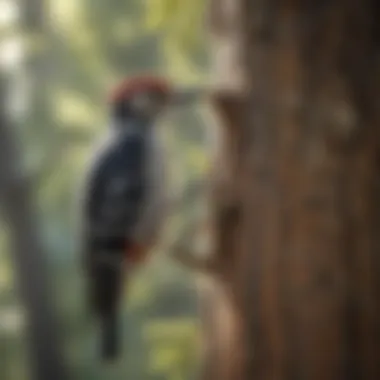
[{"left": 109, "top": 76, "right": 172, "bottom": 123}]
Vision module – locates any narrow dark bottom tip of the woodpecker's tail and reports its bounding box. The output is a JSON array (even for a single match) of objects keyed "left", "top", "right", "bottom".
[{"left": 100, "top": 313, "right": 121, "bottom": 361}]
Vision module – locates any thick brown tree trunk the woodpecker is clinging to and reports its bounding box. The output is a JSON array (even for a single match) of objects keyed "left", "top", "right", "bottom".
[{"left": 204, "top": 0, "right": 380, "bottom": 380}]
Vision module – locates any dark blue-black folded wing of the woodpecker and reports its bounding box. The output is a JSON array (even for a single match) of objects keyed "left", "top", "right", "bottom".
[{"left": 84, "top": 133, "right": 145, "bottom": 243}]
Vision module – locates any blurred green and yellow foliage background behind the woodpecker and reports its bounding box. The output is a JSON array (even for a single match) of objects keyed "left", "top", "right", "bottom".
[{"left": 0, "top": 0, "right": 208, "bottom": 380}]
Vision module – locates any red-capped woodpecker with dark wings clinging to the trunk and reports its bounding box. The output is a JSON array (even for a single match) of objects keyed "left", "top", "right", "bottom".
[{"left": 81, "top": 77, "right": 175, "bottom": 360}]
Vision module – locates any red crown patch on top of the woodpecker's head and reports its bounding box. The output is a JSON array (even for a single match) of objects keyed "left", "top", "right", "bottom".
[{"left": 109, "top": 76, "right": 171, "bottom": 103}]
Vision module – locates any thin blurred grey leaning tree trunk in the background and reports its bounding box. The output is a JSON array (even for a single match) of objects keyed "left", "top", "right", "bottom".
[{"left": 0, "top": 77, "right": 67, "bottom": 380}]
